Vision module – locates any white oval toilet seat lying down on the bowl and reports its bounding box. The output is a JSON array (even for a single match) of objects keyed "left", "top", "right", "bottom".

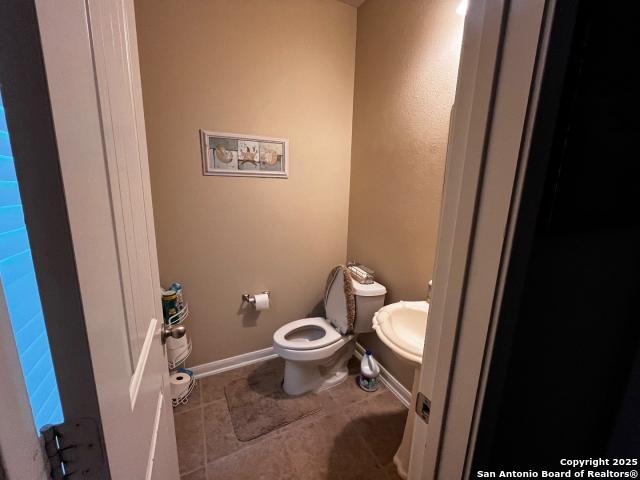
[{"left": 273, "top": 317, "right": 342, "bottom": 350}]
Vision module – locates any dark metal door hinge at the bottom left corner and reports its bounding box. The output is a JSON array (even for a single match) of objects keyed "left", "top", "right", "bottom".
[{"left": 40, "top": 418, "right": 105, "bottom": 480}]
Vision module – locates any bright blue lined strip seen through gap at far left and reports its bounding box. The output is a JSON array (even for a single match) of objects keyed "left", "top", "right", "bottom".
[{"left": 0, "top": 92, "right": 64, "bottom": 430}]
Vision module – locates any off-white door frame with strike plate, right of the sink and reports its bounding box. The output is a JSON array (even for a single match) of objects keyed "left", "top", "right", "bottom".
[{"left": 409, "top": 0, "right": 555, "bottom": 479}]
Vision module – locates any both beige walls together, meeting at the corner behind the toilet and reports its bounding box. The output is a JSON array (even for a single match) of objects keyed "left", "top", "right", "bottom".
[{"left": 136, "top": 0, "right": 463, "bottom": 386}]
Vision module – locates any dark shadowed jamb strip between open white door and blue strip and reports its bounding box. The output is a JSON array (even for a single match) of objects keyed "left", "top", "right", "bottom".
[{"left": 0, "top": 1, "right": 109, "bottom": 478}]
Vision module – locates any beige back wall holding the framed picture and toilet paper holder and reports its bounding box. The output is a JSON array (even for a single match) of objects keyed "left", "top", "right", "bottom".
[{"left": 136, "top": 0, "right": 356, "bottom": 365}]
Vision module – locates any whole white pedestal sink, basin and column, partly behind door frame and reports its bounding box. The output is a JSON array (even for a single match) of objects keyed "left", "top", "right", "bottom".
[{"left": 373, "top": 302, "right": 429, "bottom": 478}]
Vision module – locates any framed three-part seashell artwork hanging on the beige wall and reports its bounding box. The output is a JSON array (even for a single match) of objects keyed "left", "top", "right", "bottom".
[{"left": 200, "top": 130, "right": 289, "bottom": 178}]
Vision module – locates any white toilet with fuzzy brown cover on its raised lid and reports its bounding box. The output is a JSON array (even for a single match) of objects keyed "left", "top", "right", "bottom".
[{"left": 273, "top": 265, "right": 387, "bottom": 395}]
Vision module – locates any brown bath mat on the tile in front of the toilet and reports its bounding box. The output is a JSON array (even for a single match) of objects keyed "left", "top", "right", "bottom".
[{"left": 224, "top": 372, "right": 322, "bottom": 442}]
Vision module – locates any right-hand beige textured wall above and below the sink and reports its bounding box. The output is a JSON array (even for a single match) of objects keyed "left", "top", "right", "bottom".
[{"left": 347, "top": 0, "right": 464, "bottom": 387}]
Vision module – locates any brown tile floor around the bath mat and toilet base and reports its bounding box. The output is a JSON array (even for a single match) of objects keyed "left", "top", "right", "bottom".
[{"left": 175, "top": 359, "right": 407, "bottom": 480}]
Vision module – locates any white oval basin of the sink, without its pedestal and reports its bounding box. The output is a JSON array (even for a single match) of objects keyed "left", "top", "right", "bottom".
[{"left": 373, "top": 302, "right": 429, "bottom": 366}]
